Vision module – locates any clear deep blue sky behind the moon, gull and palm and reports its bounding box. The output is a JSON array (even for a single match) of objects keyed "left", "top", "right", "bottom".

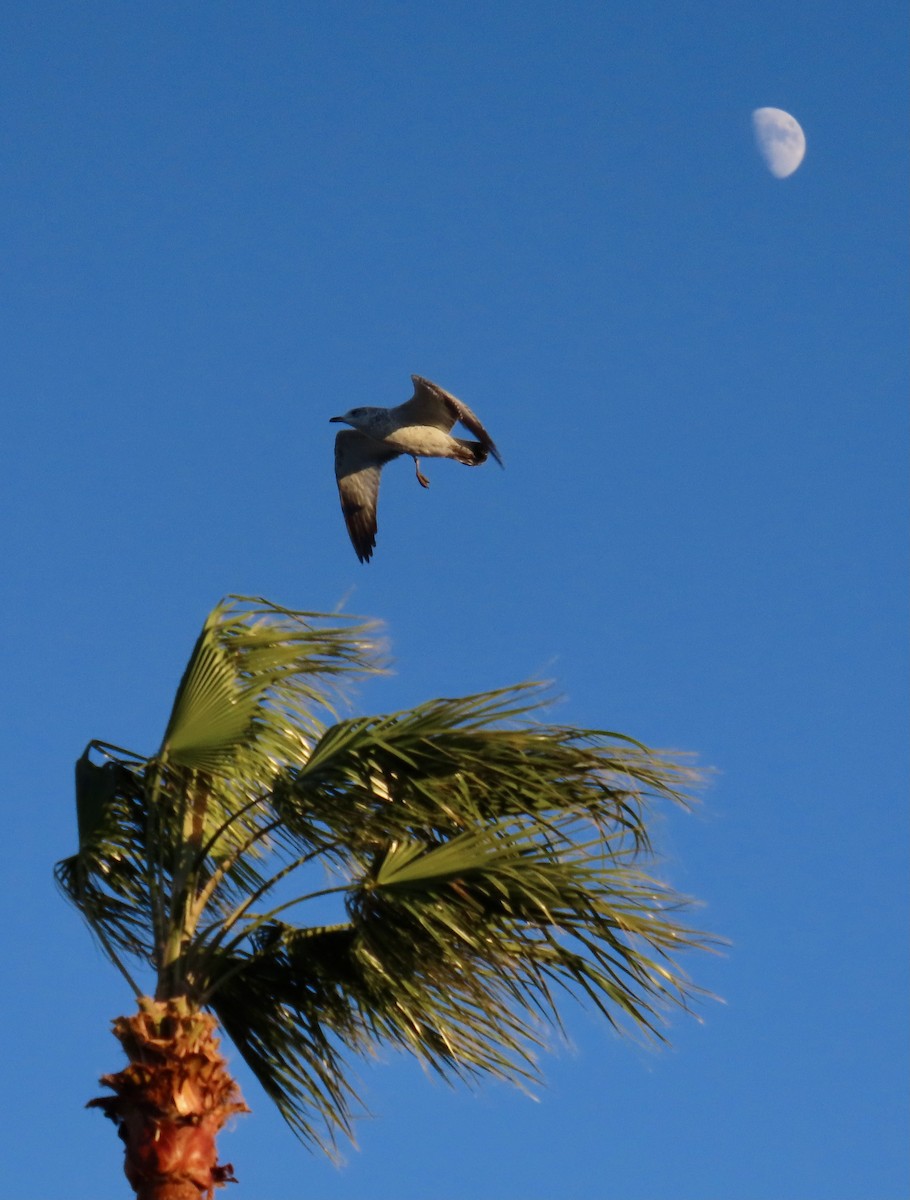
[{"left": 0, "top": 0, "right": 908, "bottom": 1200}]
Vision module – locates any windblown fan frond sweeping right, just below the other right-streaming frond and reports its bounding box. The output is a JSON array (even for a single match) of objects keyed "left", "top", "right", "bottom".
[{"left": 358, "top": 824, "right": 711, "bottom": 1033}]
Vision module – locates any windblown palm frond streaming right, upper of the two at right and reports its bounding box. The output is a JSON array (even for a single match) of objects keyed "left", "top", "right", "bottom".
[{"left": 273, "top": 688, "right": 698, "bottom": 868}]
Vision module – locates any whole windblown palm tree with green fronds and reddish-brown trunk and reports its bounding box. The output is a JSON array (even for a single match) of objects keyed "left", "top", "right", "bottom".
[{"left": 56, "top": 598, "right": 711, "bottom": 1200}]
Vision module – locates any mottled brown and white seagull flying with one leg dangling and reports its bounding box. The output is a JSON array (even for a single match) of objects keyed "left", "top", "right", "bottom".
[{"left": 329, "top": 376, "right": 503, "bottom": 563}]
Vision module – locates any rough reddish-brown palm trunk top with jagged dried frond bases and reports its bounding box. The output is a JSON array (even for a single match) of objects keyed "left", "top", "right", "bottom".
[{"left": 88, "top": 997, "right": 250, "bottom": 1200}]
